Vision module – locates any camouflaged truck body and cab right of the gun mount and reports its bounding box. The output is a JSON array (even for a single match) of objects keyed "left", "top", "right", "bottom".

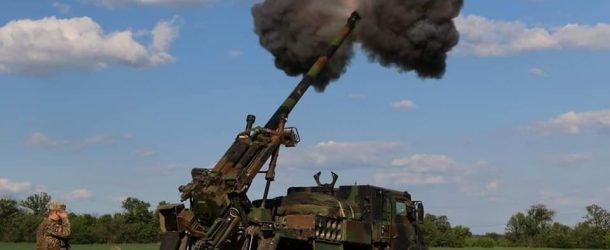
[{"left": 250, "top": 174, "right": 425, "bottom": 250}]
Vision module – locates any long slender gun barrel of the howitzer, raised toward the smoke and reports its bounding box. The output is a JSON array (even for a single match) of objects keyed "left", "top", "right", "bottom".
[{"left": 265, "top": 11, "right": 360, "bottom": 129}]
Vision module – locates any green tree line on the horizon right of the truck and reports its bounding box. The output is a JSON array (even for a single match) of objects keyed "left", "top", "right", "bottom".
[{"left": 422, "top": 204, "right": 610, "bottom": 249}]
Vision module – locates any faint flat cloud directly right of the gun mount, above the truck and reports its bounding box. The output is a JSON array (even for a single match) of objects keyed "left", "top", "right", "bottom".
[{"left": 280, "top": 141, "right": 405, "bottom": 167}]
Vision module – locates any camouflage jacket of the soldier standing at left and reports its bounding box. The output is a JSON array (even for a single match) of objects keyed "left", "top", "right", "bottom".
[{"left": 36, "top": 218, "right": 71, "bottom": 250}]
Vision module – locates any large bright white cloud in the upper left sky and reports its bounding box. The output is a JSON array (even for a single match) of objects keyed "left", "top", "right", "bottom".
[{"left": 0, "top": 17, "right": 180, "bottom": 75}]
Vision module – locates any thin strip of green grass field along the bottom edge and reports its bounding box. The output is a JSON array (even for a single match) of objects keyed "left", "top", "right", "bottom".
[{"left": 0, "top": 242, "right": 600, "bottom": 250}]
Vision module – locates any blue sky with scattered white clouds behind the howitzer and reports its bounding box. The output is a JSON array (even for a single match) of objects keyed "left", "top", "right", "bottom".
[{"left": 0, "top": 0, "right": 610, "bottom": 233}]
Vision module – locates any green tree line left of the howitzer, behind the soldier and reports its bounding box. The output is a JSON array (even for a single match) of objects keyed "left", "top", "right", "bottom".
[{"left": 0, "top": 193, "right": 159, "bottom": 244}]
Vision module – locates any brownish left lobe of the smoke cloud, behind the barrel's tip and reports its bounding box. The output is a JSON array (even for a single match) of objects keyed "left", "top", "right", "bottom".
[{"left": 252, "top": 0, "right": 353, "bottom": 90}]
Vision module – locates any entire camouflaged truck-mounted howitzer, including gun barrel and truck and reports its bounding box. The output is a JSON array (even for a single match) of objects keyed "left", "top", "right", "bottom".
[{"left": 158, "top": 12, "right": 423, "bottom": 250}]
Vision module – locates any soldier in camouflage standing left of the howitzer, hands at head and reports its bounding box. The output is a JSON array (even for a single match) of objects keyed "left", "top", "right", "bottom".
[{"left": 36, "top": 202, "right": 70, "bottom": 250}]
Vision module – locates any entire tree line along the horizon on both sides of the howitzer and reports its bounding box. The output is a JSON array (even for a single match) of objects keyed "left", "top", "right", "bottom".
[{"left": 0, "top": 193, "right": 610, "bottom": 249}]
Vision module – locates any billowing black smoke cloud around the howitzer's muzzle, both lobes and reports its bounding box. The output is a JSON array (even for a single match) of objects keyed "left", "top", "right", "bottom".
[{"left": 252, "top": 0, "right": 463, "bottom": 91}]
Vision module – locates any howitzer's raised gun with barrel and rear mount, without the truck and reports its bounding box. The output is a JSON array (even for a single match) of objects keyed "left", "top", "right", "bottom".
[{"left": 159, "top": 12, "right": 360, "bottom": 250}]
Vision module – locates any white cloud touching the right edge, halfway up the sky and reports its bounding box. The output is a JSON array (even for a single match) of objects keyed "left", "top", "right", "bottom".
[{"left": 528, "top": 109, "right": 610, "bottom": 135}]
